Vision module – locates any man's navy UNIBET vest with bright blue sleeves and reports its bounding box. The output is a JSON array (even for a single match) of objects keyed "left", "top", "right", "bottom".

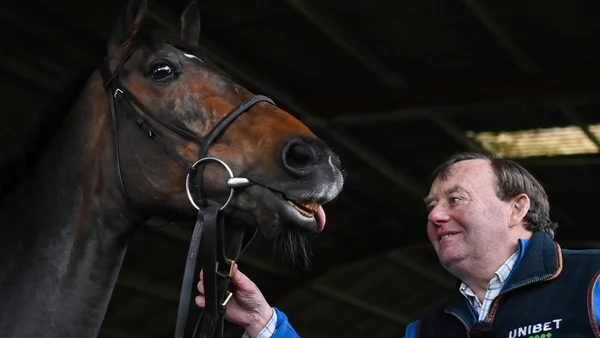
[{"left": 273, "top": 232, "right": 600, "bottom": 338}]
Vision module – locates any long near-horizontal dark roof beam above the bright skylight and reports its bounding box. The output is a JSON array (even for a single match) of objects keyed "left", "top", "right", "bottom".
[{"left": 298, "top": 73, "right": 600, "bottom": 123}]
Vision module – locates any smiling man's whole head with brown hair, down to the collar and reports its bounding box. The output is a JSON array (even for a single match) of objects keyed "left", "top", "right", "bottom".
[{"left": 425, "top": 157, "right": 536, "bottom": 307}]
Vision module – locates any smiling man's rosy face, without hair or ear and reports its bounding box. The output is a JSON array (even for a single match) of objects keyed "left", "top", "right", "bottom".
[{"left": 426, "top": 159, "right": 510, "bottom": 269}]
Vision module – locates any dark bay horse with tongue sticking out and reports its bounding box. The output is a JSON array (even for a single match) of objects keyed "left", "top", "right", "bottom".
[{"left": 0, "top": 0, "right": 344, "bottom": 338}]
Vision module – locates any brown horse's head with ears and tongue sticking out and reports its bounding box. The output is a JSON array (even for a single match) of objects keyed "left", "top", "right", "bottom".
[{"left": 104, "top": 0, "right": 343, "bottom": 237}]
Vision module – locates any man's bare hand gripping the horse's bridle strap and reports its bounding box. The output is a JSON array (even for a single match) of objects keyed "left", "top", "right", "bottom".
[{"left": 196, "top": 264, "right": 273, "bottom": 337}]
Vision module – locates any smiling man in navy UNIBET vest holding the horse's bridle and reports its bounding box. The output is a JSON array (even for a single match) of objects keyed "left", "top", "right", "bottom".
[{"left": 196, "top": 153, "right": 600, "bottom": 338}]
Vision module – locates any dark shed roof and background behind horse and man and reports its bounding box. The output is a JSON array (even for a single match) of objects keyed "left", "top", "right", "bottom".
[{"left": 0, "top": 0, "right": 600, "bottom": 338}]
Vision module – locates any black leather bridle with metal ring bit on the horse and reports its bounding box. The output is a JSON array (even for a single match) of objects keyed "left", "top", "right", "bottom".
[{"left": 100, "top": 43, "right": 275, "bottom": 338}]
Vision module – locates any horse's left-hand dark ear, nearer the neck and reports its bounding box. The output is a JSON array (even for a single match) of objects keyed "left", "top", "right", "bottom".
[{"left": 108, "top": 0, "right": 148, "bottom": 54}]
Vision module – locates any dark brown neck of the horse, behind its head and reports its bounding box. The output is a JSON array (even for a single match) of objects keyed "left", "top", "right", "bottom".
[{"left": 0, "top": 70, "right": 135, "bottom": 337}]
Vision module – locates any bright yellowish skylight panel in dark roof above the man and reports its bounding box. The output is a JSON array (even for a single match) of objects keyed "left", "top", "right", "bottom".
[{"left": 467, "top": 124, "right": 600, "bottom": 158}]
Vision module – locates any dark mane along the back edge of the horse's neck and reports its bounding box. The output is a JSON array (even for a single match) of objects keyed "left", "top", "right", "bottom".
[{"left": 0, "top": 65, "right": 97, "bottom": 206}]
